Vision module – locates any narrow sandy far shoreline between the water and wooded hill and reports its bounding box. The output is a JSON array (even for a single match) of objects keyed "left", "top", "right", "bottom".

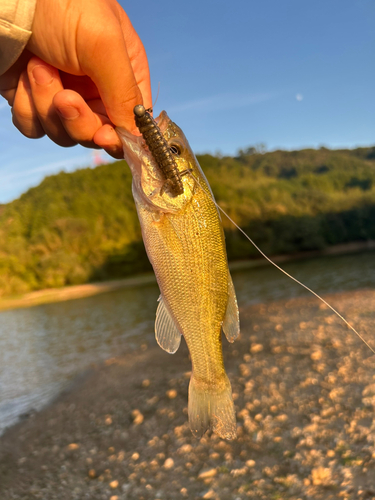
[{"left": 0, "top": 240, "right": 375, "bottom": 311}]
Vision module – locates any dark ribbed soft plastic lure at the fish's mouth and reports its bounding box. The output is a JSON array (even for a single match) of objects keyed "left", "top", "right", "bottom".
[{"left": 134, "top": 104, "right": 184, "bottom": 197}]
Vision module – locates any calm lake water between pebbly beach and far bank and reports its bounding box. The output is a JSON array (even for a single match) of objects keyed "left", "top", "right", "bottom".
[{"left": 0, "top": 252, "right": 375, "bottom": 434}]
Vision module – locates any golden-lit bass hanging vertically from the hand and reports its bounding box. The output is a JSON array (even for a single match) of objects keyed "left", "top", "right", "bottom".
[{"left": 117, "top": 111, "right": 240, "bottom": 440}]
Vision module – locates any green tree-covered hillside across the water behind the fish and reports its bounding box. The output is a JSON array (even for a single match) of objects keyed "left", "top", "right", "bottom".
[{"left": 0, "top": 147, "right": 375, "bottom": 295}]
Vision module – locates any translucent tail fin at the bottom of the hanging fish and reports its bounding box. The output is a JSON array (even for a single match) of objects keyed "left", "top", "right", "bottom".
[{"left": 189, "top": 373, "right": 236, "bottom": 439}]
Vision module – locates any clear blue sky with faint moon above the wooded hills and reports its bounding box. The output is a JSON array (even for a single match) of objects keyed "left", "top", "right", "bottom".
[{"left": 0, "top": 0, "right": 375, "bottom": 203}]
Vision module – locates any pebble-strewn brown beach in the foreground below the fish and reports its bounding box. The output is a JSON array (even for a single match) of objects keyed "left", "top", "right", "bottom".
[{"left": 0, "top": 290, "right": 375, "bottom": 500}]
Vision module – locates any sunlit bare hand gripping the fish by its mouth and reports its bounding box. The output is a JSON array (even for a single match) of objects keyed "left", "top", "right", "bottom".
[{"left": 0, "top": 0, "right": 152, "bottom": 158}]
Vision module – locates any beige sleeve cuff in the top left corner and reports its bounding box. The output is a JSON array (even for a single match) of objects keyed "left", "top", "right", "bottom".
[{"left": 0, "top": 0, "right": 36, "bottom": 75}]
